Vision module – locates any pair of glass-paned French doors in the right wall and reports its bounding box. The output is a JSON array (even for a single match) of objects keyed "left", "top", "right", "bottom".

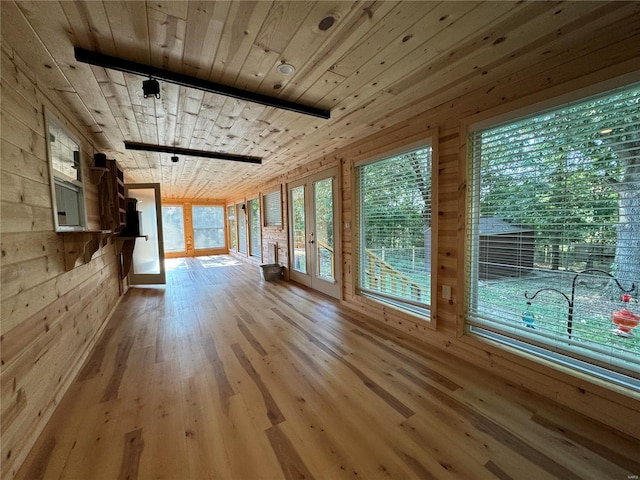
[{"left": 287, "top": 168, "right": 341, "bottom": 298}]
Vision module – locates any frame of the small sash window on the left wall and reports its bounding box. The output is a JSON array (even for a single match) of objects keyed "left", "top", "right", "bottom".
[{"left": 45, "top": 110, "right": 88, "bottom": 232}]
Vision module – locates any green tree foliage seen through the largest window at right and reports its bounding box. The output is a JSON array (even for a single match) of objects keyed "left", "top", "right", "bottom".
[{"left": 473, "top": 85, "right": 640, "bottom": 294}]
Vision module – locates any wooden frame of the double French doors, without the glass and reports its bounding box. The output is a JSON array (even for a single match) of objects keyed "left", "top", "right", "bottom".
[{"left": 286, "top": 166, "right": 342, "bottom": 300}]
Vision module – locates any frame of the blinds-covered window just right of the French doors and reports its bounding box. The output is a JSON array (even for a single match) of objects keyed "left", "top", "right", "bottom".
[{"left": 351, "top": 137, "right": 440, "bottom": 324}]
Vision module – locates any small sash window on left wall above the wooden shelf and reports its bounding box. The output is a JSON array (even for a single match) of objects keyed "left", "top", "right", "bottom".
[{"left": 47, "top": 113, "right": 87, "bottom": 232}]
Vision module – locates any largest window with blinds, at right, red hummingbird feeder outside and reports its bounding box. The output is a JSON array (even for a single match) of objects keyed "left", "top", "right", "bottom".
[{"left": 467, "top": 84, "right": 640, "bottom": 388}]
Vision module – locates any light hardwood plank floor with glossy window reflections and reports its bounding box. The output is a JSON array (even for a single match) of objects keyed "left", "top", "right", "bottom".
[{"left": 17, "top": 256, "right": 640, "bottom": 480}]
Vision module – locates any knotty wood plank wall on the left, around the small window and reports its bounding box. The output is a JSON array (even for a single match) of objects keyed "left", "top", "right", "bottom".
[{"left": 0, "top": 43, "right": 119, "bottom": 479}]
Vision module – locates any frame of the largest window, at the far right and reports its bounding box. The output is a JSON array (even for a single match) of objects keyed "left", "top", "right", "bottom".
[{"left": 457, "top": 76, "right": 640, "bottom": 390}]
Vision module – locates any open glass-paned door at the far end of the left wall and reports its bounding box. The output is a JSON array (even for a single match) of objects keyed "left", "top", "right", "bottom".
[{"left": 124, "top": 183, "right": 166, "bottom": 285}]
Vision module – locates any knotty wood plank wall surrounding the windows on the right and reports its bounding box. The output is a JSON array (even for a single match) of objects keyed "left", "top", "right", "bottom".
[{"left": 230, "top": 48, "right": 640, "bottom": 438}]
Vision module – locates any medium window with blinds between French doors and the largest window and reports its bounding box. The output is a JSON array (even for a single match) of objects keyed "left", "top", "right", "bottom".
[{"left": 355, "top": 146, "right": 431, "bottom": 315}]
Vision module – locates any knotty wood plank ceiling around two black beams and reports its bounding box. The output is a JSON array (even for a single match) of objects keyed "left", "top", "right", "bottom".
[{"left": 2, "top": 0, "right": 640, "bottom": 199}]
